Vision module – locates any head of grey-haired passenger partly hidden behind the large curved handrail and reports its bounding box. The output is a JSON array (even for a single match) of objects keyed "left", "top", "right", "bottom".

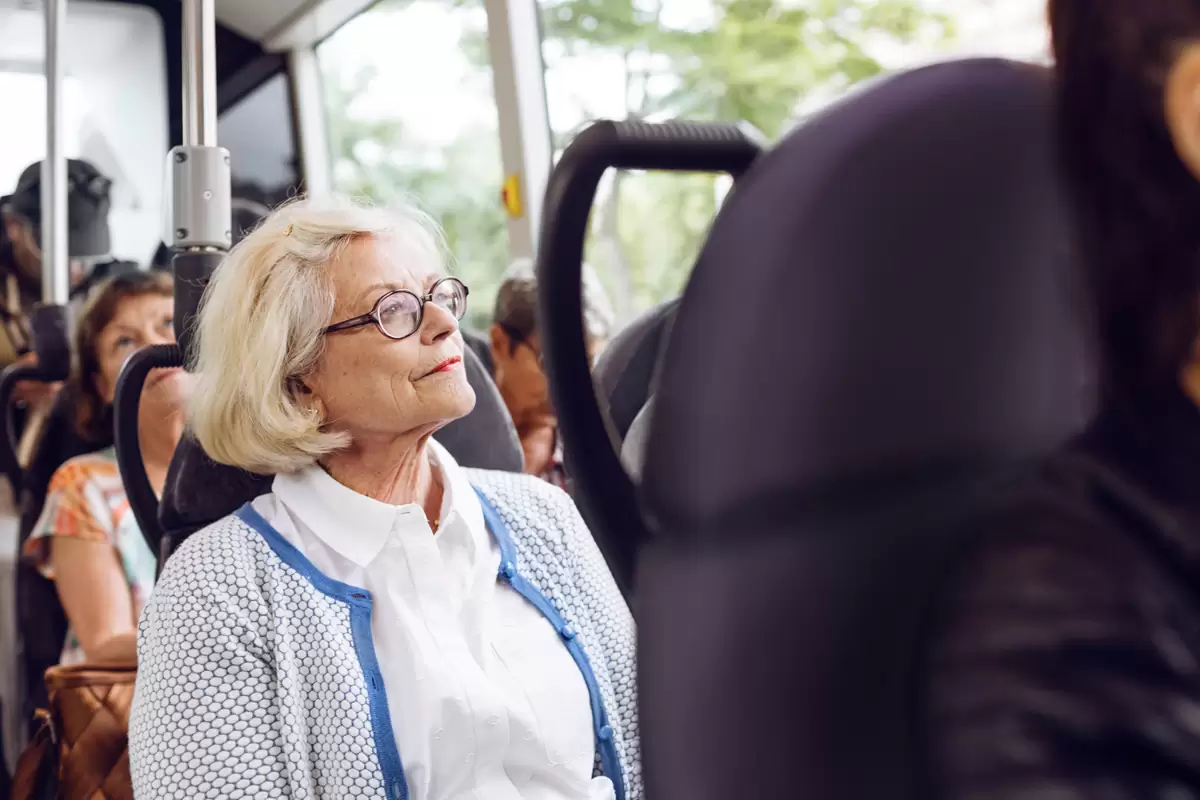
[{"left": 490, "top": 259, "right": 613, "bottom": 426}]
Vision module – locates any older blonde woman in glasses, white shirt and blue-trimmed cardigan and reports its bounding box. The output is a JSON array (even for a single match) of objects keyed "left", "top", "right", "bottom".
[{"left": 130, "top": 201, "right": 642, "bottom": 800}]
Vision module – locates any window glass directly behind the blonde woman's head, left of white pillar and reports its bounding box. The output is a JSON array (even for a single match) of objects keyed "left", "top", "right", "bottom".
[{"left": 317, "top": 0, "right": 509, "bottom": 330}]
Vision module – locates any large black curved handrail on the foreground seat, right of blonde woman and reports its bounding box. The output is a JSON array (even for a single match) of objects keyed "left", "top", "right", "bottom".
[{"left": 538, "top": 115, "right": 763, "bottom": 597}]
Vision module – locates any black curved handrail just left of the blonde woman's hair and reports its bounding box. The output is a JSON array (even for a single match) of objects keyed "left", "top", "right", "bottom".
[{"left": 113, "top": 344, "right": 184, "bottom": 563}]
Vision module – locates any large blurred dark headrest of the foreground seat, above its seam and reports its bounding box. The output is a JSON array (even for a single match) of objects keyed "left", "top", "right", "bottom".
[{"left": 647, "top": 60, "right": 1086, "bottom": 532}]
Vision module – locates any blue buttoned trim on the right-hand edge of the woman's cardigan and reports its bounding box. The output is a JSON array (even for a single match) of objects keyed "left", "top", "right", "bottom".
[{"left": 474, "top": 487, "right": 625, "bottom": 800}]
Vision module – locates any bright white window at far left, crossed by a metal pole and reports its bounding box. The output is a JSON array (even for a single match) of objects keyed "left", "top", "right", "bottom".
[{"left": 0, "top": 1, "right": 168, "bottom": 261}]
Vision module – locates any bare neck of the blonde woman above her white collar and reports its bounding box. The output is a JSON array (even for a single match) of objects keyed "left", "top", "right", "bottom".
[{"left": 322, "top": 434, "right": 443, "bottom": 519}]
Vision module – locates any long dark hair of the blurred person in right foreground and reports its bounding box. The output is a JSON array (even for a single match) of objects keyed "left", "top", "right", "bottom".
[{"left": 1049, "top": 0, "right": 1200, "bottom": 403}]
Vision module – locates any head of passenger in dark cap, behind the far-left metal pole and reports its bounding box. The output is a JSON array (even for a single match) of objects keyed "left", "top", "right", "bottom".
[{"left": 2, "top": 158, "right": 112, "bottom": 289}]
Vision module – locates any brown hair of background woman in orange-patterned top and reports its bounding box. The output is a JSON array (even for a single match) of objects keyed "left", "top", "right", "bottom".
[{"left": 67, "top": 270, "right": 174, "bottom": 443}]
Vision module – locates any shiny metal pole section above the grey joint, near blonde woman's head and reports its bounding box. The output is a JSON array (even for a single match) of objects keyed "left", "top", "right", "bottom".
[{"left": 184, "top": 0, "right": 217, "bottom": 148}]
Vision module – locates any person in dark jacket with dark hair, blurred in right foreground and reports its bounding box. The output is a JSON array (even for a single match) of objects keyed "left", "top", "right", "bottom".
[{"left": 926, "top": 0, "right": 1200, "bottom": 800}]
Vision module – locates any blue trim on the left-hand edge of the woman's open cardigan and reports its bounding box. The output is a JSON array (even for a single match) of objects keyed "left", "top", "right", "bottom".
[{"left": 234, "top": 503, "right": 408, "bottom": 800}]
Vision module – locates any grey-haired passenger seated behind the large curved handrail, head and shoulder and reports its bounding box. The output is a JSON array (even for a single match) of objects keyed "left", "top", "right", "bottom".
[{"left": 465, "top": 259, "right": 613, "bottom": 488}]
